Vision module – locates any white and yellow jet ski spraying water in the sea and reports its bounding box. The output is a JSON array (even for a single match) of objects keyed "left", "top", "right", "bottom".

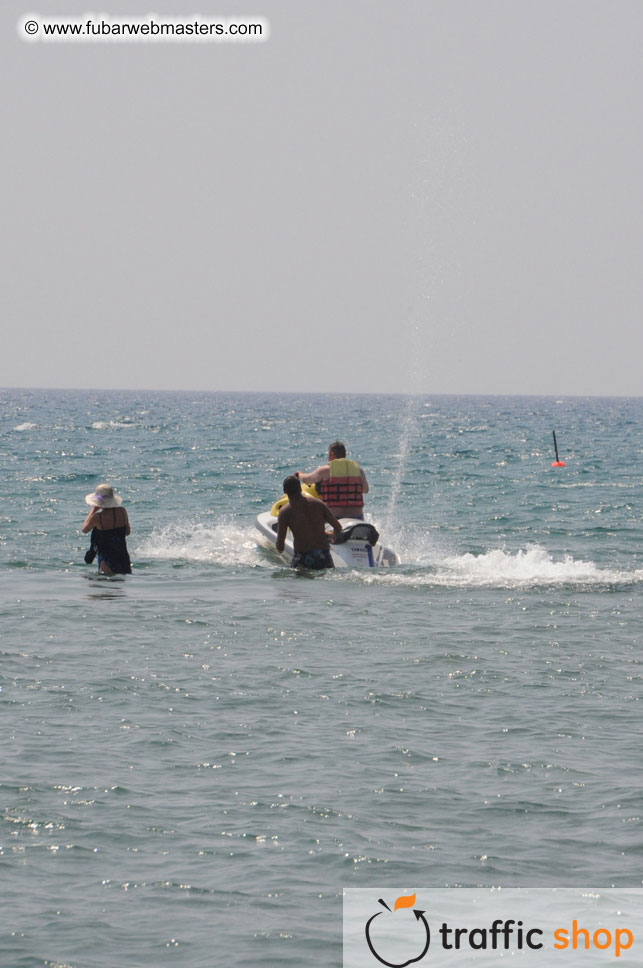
[{"left": 255, "top": 484, "right": 400, "bottom": 568}]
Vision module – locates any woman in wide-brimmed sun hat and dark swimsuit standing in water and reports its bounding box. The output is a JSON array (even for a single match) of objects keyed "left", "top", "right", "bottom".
[{"left": 83, "top": 484, "right": 132, "bottom": 575}]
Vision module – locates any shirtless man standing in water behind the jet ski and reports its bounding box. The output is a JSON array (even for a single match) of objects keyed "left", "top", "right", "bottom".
[{"left": 277, "top": 477, "right": 342, "bottom": 570}]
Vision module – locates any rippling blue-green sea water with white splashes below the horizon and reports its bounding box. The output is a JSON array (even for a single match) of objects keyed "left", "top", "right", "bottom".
[{"left": 0, "top": 390, "right": 643, "bottom": 968}]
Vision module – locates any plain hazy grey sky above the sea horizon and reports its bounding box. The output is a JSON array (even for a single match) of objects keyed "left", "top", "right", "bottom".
[{"left": 0, "top": 0, "right": 643, "bottom": 396}]
